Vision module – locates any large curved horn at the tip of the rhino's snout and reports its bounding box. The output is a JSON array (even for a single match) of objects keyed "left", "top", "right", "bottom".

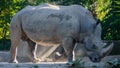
[{"left": 101, "top": 43, "right": 114, "bottom": 57}]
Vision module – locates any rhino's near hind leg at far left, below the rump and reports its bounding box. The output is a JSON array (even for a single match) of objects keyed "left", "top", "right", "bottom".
[{"left": 9, "top": 23, "right": 21, "bottom": 63}]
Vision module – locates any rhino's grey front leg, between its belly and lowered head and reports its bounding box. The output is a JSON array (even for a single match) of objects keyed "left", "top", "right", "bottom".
[{"left": 62, "top": 37, "right": 75, "bottom": 65}]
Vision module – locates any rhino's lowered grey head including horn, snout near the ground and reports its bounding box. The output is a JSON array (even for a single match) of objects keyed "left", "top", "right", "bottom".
[{"left": 84, "top": 19, "right": 113, "bottom": 62}]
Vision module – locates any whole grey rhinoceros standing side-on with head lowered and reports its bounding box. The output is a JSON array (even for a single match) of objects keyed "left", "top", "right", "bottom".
[{"left": 10, "top": 4, "right": 113, "bottom": 64}]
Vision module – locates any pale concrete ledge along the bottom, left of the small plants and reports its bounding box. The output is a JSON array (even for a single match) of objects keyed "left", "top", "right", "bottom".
[{"left": 0, "top": 63, "right": 69, "bottom": 68}]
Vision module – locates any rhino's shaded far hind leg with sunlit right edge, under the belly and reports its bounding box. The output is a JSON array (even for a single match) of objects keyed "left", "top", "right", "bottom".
[{"left": 27, "top": 39, "right": 40, "bottom": 63}]
